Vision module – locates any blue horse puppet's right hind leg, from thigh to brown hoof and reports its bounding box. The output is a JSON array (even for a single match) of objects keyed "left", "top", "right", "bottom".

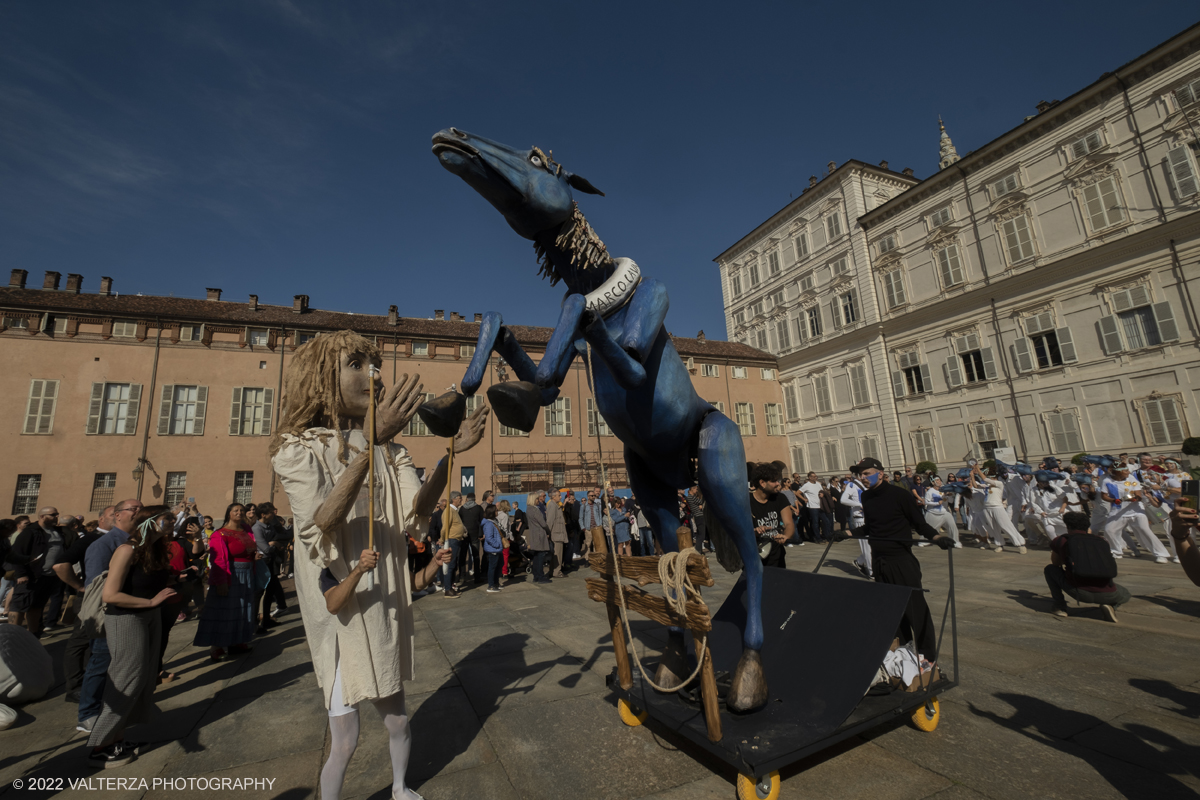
[{"left": 696, "top": 410, "right": 768, "bottom": 714}]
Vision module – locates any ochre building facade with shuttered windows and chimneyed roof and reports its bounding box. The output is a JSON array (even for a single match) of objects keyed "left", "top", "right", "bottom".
[{"left": 0, "top": 270, "right": 787, "bottom": 517}]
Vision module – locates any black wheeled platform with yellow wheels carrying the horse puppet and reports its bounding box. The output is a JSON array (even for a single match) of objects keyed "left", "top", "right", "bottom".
[{"left": 610, "top": 552, "right": 958, "bottom": 782}]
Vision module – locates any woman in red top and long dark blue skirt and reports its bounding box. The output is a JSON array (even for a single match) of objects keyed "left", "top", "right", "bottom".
[{"left": 193, "top": 503, "right": 258, "bottom": 661}]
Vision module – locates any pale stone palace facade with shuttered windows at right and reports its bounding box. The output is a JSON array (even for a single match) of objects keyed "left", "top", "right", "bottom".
[{"left": 715, "top": 26, "right": 1200, "bottom": 473}]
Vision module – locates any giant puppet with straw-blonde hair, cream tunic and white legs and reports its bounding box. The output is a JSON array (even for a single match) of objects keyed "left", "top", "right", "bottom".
[{"left": 271, "top": 331, "right": 487, "bottom": 800}]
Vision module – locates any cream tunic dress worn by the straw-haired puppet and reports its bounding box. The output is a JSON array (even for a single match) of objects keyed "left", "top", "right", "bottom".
[{"left": 271, "top": 428, "right": 427, "bottom": 709}]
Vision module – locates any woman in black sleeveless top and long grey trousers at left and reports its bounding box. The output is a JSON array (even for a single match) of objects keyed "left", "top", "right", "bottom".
[{"left": 88, "top": 506, "right": 175, "bottom": 769}]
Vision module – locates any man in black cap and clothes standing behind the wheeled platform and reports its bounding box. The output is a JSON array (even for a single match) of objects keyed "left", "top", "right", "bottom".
[{"left": 834, "top": 458, "right": 954, "bottom": 661}]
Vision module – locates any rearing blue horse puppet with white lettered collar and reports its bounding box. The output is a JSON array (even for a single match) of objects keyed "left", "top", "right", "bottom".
[{"left": 433, "top": 128, "right": 768, "bottom": 712}]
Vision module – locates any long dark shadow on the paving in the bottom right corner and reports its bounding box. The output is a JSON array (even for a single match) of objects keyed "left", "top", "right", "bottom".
[{"left": 967, "top": 692, "right": 1200, "bottom": 798}]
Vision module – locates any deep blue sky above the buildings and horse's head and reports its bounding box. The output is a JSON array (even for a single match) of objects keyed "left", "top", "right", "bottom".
[{"left": 0, "top": 0, "right": 1200, "bottom": 338}]
